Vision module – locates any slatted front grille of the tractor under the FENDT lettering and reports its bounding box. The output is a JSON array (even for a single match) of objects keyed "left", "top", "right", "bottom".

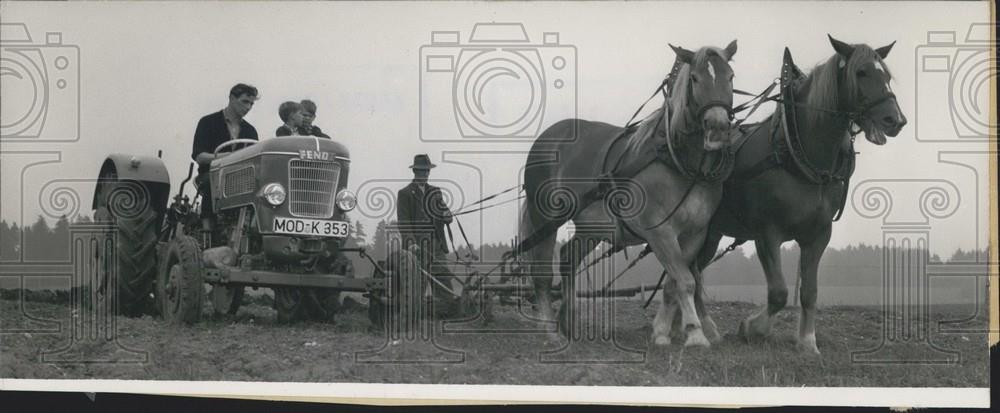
[{"left": 288, "top": 159, "right": 340, "bottom": 218}]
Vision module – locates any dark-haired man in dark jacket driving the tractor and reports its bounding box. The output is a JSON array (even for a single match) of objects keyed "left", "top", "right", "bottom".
[{"left": 191, "top": 83, "right": 258, "bottom": 229}]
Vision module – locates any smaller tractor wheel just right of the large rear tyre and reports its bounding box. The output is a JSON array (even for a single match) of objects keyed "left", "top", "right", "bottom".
[{"left": 156, "top": 235, "right": 205, "bottom": 324}]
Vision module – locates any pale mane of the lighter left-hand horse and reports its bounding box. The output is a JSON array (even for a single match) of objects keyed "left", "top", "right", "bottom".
[{"left": 626, "top": 46, "right": 731, "bottom": 151}]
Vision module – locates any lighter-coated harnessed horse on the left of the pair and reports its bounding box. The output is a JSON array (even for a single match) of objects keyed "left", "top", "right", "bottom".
[{"left": 519, "top": 40, "right": 736, "bottom": 346}]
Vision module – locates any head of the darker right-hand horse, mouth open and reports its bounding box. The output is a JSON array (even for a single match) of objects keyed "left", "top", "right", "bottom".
[{"left": 827, "top": 35, "right": 906, "bottom": 145}]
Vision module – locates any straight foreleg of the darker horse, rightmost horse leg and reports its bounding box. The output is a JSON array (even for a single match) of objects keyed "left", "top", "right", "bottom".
[{"left": 796, "top": 225, "right": 831, "bottom": 354}]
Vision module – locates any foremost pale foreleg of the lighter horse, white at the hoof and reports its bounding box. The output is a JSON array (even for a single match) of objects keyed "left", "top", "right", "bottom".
[{"left": 649, "top": 233, "right": 711, "bottom": 347}]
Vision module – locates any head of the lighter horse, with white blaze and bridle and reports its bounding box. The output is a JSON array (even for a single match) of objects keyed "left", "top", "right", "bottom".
[{"left": 670, "top": 40, "right": 737, "bottom": 151}]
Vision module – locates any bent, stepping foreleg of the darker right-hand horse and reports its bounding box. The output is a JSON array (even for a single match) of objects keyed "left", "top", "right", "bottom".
[{"left": 739, "top": 231, "right": 788, "bottom": 339}]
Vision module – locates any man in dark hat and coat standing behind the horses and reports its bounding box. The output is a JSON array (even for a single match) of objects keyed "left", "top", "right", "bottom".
[{"left": 396, "top": 154, "right": 457, "bottom": 314}]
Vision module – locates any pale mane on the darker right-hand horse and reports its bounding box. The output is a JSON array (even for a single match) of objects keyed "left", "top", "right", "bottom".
[{"left": 799, "top": 44, "right": 892, "bottom": 123}]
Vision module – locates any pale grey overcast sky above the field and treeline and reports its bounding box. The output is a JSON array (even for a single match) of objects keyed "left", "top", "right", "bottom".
[{"left": 0, "top": 2, "right": 996, "bottom": 254}]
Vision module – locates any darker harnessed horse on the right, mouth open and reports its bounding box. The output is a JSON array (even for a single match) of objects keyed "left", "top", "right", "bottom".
[{"left": 680, "top": 35, "right": 906, "bottom": 355}]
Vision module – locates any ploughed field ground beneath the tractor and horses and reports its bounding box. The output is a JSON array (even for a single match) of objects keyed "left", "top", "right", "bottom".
[{"left": 0, "top": 295, "right": 989, "bottom": 387}]
